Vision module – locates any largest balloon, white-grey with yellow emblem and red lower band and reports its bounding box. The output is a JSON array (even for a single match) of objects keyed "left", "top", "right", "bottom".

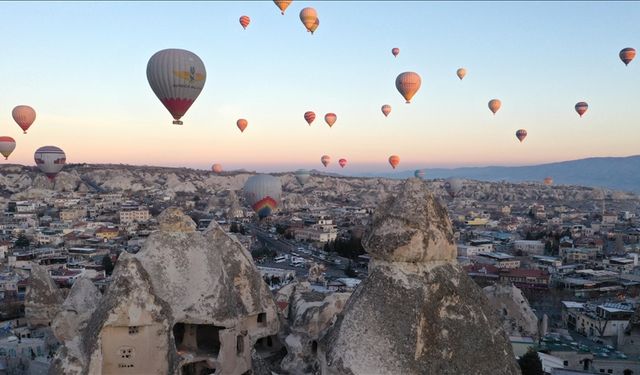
[{"left": 147, "top": 49, "right": 207, "bottom": 125}]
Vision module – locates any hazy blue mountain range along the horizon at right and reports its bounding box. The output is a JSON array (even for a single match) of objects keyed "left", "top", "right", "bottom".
[{"left": 361, "top": 155, "right": 640, "bottom": 193}]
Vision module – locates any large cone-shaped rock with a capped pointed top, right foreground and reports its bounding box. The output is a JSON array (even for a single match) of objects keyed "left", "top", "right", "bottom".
[{"left": 318, "top": 179, "right": 520, "bottom": 375}]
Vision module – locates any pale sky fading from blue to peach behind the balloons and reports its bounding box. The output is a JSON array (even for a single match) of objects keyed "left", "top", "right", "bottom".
[{"left": 0, "top": 1, "right": 640, "bottom": 174}]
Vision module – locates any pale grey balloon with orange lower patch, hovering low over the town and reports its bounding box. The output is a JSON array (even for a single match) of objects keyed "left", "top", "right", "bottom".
[{"left": 243, "top": 174, "right": 282, "bottom": 219}]
